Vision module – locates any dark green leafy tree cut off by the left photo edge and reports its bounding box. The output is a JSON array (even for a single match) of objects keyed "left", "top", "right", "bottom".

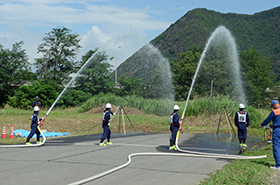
[{"left": 0, "top": 41, "right": 36, "bottom": 105}]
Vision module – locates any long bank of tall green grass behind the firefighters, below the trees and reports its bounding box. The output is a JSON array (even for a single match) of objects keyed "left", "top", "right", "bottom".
[{"left": 77, "top": 93, "right": 270, "bottom": 128}]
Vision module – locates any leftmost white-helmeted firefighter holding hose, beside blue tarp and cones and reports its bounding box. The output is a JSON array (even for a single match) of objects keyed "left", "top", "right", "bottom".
[{"left": 26, "top": 106, "right": 42, "bottom": 145}]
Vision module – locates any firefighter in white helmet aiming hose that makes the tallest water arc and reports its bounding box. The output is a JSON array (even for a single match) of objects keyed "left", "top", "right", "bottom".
[{"left": 169, "top": 105, "right": 180, "bottom": 150}]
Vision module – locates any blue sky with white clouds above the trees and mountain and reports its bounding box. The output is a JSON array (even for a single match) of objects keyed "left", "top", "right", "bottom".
[{"left": 0, "top": 0, "right": 280, "bottom": 70}]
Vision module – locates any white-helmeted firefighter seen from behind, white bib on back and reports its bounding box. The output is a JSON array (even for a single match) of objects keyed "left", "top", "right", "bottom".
[{"left": 235, "top": 104, "right": 250, "bottom": 148}]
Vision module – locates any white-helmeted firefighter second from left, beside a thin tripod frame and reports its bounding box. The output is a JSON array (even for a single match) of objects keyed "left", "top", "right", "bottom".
[{"left": 99, "top": 103, "right": 113, "bottom": 146}]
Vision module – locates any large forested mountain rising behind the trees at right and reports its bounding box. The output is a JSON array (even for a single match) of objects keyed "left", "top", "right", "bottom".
[{"left": 117, "top": 7, "right": 280, "bottom": 78}]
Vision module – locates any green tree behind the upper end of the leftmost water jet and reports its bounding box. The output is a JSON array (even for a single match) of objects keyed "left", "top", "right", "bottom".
[{"left": 76, "top": 49, "right": 113, "bottom": 95}]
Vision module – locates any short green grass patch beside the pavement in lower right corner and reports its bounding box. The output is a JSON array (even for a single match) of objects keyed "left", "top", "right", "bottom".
[{"left": 201, "top": 145, "right": 276, "bottom": 185}]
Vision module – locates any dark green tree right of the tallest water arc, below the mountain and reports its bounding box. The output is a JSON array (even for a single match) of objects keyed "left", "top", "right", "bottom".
[{"left": 241, "top": 48, "right": 277, "bottom": 107}]
